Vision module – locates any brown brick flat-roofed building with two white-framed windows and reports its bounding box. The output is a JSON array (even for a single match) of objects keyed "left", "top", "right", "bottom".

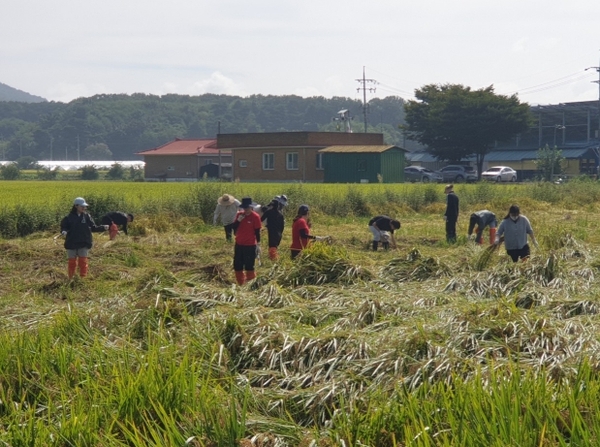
[{"left": 217, "top": 132, "right": 383, "bottom": 182}]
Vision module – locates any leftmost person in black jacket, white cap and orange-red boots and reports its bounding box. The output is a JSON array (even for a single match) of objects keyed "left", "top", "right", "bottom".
[{"left": 60, "top": 197, "right": 108, "bottom": 279}]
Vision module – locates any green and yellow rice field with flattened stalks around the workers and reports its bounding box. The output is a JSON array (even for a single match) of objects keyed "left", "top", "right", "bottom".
[{"left": 0, "top": 181, "right": 600, "bottom": 447}]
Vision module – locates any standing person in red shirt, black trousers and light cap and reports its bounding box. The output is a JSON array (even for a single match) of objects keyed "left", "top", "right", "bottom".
[{"left": 233, "top": 197, "right": 261, "bottom": 286}]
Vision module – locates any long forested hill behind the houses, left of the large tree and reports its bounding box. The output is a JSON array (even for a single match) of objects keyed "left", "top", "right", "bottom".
[{"left": 0, "top": 94, "right": 410, "bottom": 160}]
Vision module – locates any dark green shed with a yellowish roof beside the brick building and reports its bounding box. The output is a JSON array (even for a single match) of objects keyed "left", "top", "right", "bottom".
[{"left": 319, "top": 145, "right": 406, "bottom": 183}]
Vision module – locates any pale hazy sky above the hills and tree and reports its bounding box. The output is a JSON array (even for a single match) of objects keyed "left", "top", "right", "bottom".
[{"left": 0, "top": 0, "right": 600, "bottom": 105}]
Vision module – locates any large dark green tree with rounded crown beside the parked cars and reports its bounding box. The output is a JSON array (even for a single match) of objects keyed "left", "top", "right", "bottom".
[{"left": 402, "top": 84, "right": 532, "bottom": 177}]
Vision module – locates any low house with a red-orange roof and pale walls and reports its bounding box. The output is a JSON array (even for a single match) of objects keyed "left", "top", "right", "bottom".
[{"left": 137, "top": 138, "right": 231, "bottom": 181}]
